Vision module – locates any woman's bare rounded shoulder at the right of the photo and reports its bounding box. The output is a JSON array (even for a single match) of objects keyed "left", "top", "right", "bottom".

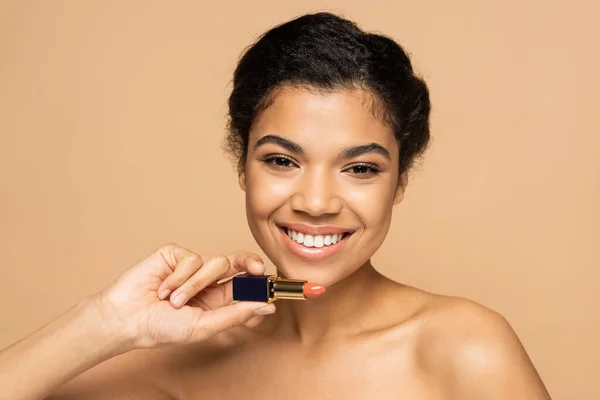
[{"left": 415, "top": 294, "right": 550, "bottom": 399}]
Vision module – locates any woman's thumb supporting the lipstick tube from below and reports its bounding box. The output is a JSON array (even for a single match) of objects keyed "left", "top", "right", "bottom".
[{"left": 191, "top": 301, "right": 275, "bottom": 341}]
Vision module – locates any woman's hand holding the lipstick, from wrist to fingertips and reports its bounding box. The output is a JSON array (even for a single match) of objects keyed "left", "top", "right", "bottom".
[{"left": 95, "top": 244, "right": 275, "bottom": 348}]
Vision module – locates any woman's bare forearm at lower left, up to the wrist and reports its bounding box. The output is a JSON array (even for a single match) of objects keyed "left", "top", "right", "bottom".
[{"left": 0, "top": 297, "right": 135, "bottom": 399}]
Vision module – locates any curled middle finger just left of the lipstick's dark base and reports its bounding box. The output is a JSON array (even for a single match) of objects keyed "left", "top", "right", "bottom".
[{"left": 171, "top": 256, "right": 231, "bottom": 308}]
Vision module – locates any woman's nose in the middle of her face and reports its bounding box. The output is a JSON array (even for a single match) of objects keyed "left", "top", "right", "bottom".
[{"left": 291, "top": 170, "right": 343, "bottom": 217}]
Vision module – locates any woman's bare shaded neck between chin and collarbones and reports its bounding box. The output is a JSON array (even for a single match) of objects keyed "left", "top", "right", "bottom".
[{"left": 261, "top": 261, "right": 387, "bottom": 344}]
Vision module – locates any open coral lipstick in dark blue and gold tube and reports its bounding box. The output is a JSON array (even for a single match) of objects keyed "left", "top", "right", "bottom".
[{"left": 232, "top": 275, "right": 325, "bottom": 303}]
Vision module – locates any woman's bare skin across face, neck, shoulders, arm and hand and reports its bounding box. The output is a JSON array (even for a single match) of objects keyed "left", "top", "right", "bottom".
[{"left": 0, "top": 88, "right": 550, "bottom": 400}]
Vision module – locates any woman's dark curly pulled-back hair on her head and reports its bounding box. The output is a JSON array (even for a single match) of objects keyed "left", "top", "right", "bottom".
[{"left": 224, "top": 12, "right": 431, "bottom": 174}]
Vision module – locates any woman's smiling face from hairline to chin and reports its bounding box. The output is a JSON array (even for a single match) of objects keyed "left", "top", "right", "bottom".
[{"left": 240, "top": 87, "right": 405, "bottom": 286}]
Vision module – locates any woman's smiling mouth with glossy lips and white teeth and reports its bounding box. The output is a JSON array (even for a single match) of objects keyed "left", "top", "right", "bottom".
[{"left": 278, "top": 224, "right": 354, "bottom": 259}]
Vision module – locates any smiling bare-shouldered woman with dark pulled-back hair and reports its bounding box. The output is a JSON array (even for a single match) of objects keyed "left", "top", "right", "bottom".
[{"left": 0, "top": 13, "right": 549, "bottom": 399}]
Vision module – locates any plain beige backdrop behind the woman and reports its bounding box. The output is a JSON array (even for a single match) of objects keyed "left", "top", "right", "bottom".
[{"left": 0, "top": 0, "right": 600, "bottom": 399}]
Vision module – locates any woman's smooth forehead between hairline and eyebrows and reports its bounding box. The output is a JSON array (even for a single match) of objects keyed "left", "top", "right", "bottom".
[{"left": 249, "top": 87, "right": 398, "bottom": 155}]
